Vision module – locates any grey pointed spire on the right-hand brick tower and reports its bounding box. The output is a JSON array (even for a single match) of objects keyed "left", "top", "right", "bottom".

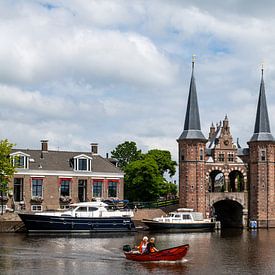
[{"left": 250, "top": 66, "right": 274, "bottom": 141}]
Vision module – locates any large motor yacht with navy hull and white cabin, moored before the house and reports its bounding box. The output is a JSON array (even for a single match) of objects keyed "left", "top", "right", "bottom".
[{"left": 18, "top": 202, "right": 136, "bottom": 233}]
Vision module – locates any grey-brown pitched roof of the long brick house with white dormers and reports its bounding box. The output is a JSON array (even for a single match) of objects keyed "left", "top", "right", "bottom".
[{"left": 12, "top": 149, "right": 122, "bottom": 173}]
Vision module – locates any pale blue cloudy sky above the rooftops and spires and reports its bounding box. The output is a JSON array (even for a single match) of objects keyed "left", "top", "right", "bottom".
[{"left": 0, "top": 0, "right": 275, "bottom": 178}]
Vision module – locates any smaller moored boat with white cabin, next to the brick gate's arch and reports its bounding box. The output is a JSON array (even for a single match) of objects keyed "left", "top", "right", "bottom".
[{"left": 142, "top": 208, "right": 216, "bottom": 231}]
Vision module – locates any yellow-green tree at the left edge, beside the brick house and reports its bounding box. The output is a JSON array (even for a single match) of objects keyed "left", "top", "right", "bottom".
[{"left": 0, "top": 139, "right": 16, "bottom": 214}]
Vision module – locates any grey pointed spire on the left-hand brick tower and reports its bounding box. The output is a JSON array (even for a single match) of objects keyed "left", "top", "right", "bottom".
[{"left": 179, "top": 55, "right": 205, "bottom": 140}]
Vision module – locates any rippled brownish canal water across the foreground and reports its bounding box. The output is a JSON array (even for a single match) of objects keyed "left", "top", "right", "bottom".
[{"left": 0, "top": 229, "right": 275, "bottom": 275}]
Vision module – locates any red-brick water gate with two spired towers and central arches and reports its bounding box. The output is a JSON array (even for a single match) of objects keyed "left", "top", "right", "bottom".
[{"left": 177, "top": 60, "right": 275, "bottom": 228}]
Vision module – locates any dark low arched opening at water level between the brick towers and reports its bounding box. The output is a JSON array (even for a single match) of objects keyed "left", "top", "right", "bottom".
[{"left": 213, "top": 199, "right": 244, "bottom": 228}]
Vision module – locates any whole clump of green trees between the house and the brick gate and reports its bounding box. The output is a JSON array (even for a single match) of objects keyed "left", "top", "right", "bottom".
[{"left": 115, "top": 141, "right": 177, "bottom": 201}]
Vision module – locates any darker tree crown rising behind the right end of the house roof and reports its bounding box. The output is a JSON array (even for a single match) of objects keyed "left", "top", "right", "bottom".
[{"left": 111, "top": 141, "right": 141, "bottom": 171}]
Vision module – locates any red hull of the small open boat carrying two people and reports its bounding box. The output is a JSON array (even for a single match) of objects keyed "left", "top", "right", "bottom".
[{"left": 124, "top": 244, "right": 189, "bottom": 262}]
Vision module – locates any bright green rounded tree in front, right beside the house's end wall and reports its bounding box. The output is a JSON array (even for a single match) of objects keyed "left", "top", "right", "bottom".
[{"left": 124, "top": 158, "right": 163, "bottom": 201}]
